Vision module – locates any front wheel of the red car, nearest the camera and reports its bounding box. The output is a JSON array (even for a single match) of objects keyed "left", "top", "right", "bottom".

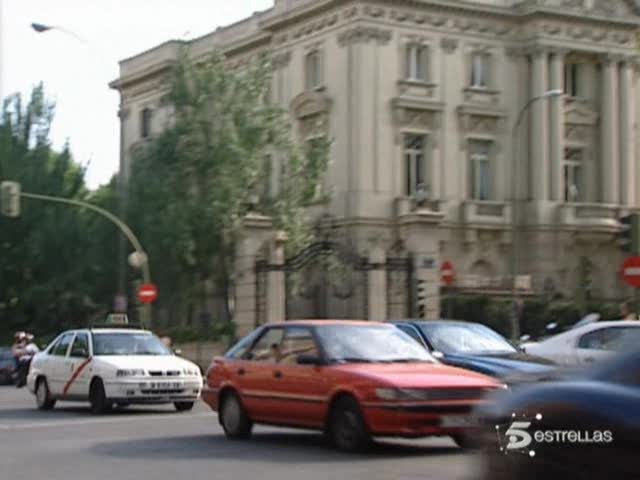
[{"left": 328, "top": 397, "right": 371, "bottom": 452}]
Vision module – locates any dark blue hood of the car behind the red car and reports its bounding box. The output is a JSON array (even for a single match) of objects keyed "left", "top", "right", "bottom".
[{"left": 442, "top": 352, "right": 555, "bottom": 377}]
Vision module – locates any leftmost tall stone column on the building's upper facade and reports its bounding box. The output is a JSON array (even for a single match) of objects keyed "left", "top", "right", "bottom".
[{"left": 529, "top": 49, "right": 549, "bottom": 202}]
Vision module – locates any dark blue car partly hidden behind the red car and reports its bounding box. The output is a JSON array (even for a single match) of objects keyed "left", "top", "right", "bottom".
[{"left": 392, "top": 320, "right": 555, "bottom": 383}]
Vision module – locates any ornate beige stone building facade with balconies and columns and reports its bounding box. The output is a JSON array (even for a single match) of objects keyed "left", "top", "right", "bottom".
[{"left": 112, "top": 0, "right": 640, "bottom": 330}]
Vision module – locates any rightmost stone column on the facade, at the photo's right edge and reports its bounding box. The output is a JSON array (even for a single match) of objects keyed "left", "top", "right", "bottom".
[{"left": 620, "top": 60, "right": 637, "bottom": 206}]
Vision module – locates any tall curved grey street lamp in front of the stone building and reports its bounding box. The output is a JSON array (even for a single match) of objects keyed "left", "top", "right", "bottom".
[{"left": 511, "top": 89, "right": 564, "bottom": 340}]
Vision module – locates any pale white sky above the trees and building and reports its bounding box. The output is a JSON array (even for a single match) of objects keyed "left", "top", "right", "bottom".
[{"left": 0, "top": 0, "right": 273, "bottom": 188}]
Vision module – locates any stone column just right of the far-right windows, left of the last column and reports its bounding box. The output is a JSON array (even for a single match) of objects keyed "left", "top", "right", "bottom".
[{"left": 600, "top": 55, "right": 620, "bottom": 204}]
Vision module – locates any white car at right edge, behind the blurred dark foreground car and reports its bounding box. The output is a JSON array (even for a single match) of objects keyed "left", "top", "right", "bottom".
[{"left": 522, "top": 320, "right": 640, "bottom": 366}]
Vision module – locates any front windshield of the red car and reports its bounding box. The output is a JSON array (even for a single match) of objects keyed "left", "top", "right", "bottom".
[{"left": 316, "top": 325, "right": 437, "bottom": 363}]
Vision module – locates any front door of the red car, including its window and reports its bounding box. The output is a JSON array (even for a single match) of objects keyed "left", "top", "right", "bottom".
[{"left": 270, "top": 327, "right": 331, "bottom": 427}]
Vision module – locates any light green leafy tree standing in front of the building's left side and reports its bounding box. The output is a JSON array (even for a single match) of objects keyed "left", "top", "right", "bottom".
[{"left": 129, "top": 51, "right": 329, "bottom": 326}]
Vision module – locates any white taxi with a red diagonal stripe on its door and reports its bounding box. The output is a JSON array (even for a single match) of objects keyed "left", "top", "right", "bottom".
[{"left": 27, "top": 328, "right": 202, "bottom": 413}]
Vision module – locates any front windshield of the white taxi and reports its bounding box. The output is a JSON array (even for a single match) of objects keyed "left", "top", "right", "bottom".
[{"left": 93, "top": 332, "right": 171, "bottom": 355}]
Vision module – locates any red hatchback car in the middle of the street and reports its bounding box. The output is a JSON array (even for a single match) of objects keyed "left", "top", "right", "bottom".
[{"left": 202, "top": 320, "right": 503, "bottom": 451}]
